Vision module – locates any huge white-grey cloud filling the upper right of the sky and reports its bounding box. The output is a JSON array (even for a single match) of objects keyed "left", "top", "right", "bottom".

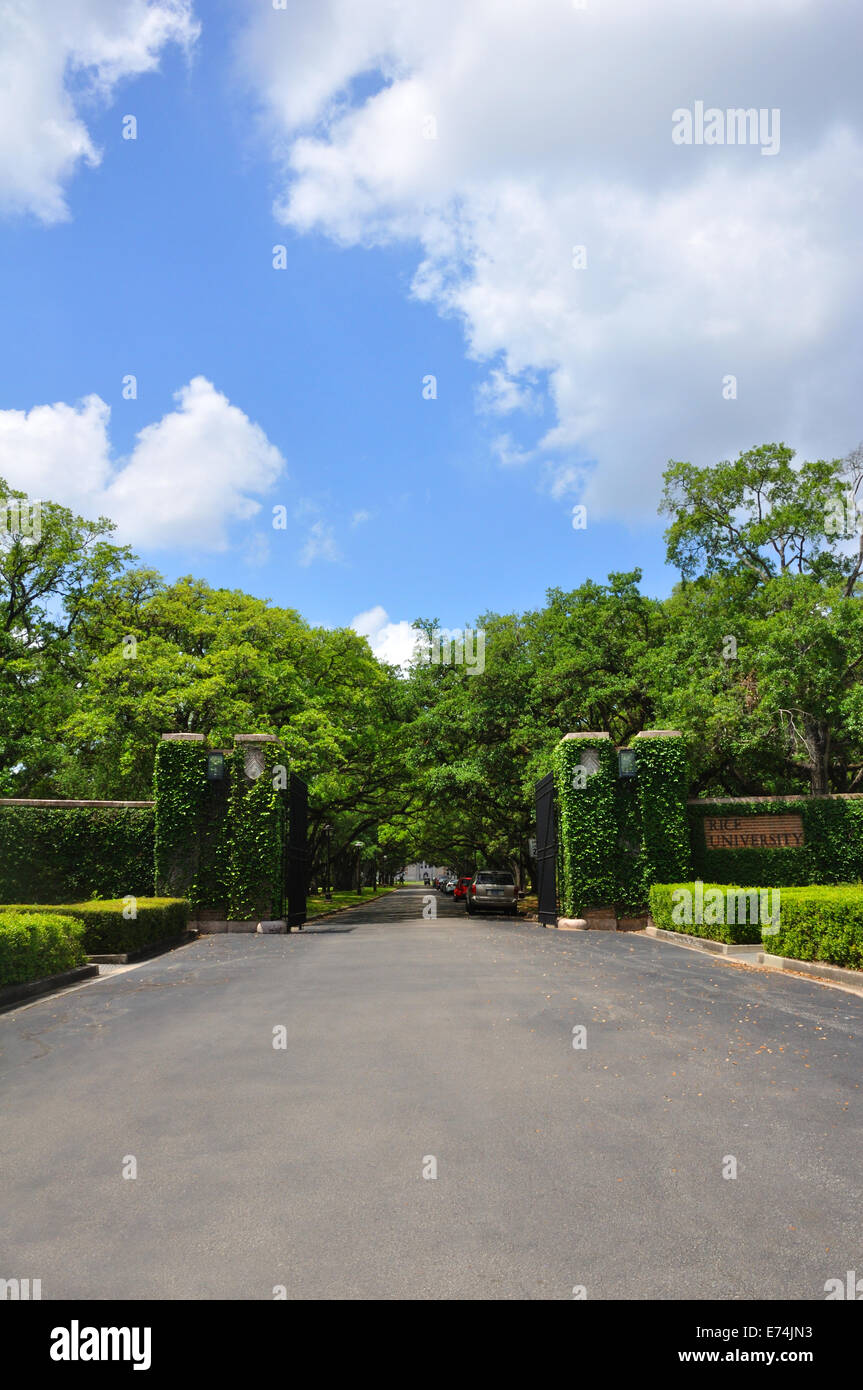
[{"left": 245, "top": 0, "right": 863, "bottom": 517}]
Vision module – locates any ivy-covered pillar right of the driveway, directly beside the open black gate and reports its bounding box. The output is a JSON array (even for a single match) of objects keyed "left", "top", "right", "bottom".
[{"left": 553, "top": 733, "right": 617, "bottom": 919}]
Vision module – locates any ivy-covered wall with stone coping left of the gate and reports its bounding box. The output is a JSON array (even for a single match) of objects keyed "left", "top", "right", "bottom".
[{"left": 0, "top": 806, "right": 154, "bottom": 906}]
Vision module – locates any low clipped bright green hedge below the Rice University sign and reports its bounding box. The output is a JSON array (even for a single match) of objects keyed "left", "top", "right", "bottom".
[{"left": 650, "top": 883, "right": 863, "bottom": 970}]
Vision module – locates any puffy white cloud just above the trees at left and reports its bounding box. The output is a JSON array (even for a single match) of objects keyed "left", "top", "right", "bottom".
[{"left": 0, "top": 377, "right": 283, "bottom": 550}]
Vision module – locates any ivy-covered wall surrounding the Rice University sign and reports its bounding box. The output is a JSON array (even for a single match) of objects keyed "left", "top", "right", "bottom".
[{"left": 687, "top": 796, "right": 863, "bottom": 887}]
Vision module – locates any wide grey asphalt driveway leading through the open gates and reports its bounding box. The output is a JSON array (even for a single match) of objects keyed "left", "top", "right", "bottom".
[{"left": 0, "top": 890, "right": 863, "bottom": 1300}]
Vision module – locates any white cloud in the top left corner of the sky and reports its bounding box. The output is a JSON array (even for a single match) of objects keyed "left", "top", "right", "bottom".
[{"left": 0, "top": 0, "right": 199, "bottom": 222}]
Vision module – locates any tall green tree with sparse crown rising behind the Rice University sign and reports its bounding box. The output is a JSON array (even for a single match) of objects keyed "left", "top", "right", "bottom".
[{"left": 656, "top": 445, "right": 863, "bottom": 795}]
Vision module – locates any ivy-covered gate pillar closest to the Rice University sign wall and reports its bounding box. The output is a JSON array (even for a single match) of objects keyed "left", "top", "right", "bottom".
[{"left": 634, "top": 728, "right": 692, "bottom": 901}]
